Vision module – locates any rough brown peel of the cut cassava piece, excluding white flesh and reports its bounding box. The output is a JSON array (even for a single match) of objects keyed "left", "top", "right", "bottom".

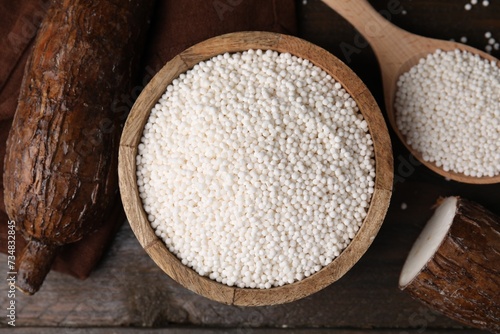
[{"left": 402, "top": 198, "right": 500, "bottom": 333}]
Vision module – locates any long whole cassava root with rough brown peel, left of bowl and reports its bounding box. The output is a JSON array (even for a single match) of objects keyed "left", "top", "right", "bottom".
[{"left": 3, "top": 0, "right": 154, "bottom": 294}]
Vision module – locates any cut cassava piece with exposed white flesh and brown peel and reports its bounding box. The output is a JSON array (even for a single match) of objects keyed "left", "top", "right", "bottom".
[{"left": 399, "top": 197, "right": 500, "bottom": 333}]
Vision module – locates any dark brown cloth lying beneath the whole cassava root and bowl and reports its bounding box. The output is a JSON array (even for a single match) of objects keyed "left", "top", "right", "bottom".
[{"left": 0, "top": 0, "right": 296, "bottom": 279}]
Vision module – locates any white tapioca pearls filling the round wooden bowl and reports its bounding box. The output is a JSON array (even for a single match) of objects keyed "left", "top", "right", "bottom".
[{"left": 137, "top": 50, "right": 375, "bottom": 289}]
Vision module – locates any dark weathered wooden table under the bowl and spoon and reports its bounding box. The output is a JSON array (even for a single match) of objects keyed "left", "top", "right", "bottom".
[{"left": 0, "top": 0, "right": 500, "bottom": 334}]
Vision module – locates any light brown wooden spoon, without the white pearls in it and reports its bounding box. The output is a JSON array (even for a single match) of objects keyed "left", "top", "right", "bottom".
[{"left": 322, "top": 0, "right": 500, "bottom": 184}]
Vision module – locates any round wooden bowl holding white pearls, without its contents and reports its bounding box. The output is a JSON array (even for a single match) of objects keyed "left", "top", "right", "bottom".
[{"left": 118, "top": 32, "right": 393, "bottom": 306}]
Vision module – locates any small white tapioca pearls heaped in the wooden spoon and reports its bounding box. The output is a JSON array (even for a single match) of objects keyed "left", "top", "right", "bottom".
[{"left": 395, "top": 50, "right": 500, "bottom": 177}]
